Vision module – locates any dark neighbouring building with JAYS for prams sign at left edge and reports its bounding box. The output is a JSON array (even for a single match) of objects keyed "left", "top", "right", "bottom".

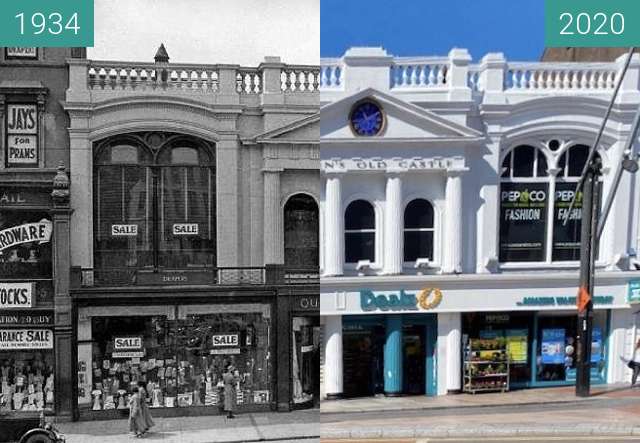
[{"left": 0, "top": 47, "right": 85, "bottom": 417}]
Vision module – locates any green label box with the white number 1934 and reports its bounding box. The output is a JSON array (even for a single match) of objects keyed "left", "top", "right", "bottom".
[{"left": 0, "top": 0, "right": 93, "bottom": 47}]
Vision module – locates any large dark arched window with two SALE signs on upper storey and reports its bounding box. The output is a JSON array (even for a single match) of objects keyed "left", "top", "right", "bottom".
[{"left": 94, "top": 133, "right": 216, "bottom": 278}]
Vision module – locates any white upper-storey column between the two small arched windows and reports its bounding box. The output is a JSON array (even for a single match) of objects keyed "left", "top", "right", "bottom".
[{"left": 383, "top": 174, "right": 404, "bottom": 275}]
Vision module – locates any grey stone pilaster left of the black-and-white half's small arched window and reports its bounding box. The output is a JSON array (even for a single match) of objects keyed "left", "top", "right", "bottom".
[{"left": 263, "top": 170, "right": 284, "bottom": 264}]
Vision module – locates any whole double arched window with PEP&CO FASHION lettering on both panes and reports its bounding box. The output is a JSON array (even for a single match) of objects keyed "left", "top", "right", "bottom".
[{"left": 500, "top": 140, "right": 597, "bottom": 262}]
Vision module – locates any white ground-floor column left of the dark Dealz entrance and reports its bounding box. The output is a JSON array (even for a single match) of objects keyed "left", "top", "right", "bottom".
[{"left": 324, "top": 315, "right": 344, "bottom": 399}]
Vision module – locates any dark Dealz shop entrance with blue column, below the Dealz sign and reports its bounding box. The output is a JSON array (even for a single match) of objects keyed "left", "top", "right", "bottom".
[{"left": 343, "top": 314, "right": 437, "bottom": 397}]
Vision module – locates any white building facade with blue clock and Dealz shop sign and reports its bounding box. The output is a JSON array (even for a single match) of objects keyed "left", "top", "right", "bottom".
[{"left": 320, "top": 48, "right": 640, "bottom": 399}]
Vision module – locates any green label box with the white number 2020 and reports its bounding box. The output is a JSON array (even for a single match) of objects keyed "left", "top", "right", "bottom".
[{"left": 544, "top": 0, "right": 640, "bottom": 47}]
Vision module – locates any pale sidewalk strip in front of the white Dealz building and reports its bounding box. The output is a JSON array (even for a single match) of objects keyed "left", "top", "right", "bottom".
[{"left": 320, "top": 384, "right": 640, "bottom": 414}]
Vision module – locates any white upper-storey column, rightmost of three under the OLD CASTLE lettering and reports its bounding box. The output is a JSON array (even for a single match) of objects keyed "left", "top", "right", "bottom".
[{"left": 442, "top": 169, "right": 465, "bottom": 274}]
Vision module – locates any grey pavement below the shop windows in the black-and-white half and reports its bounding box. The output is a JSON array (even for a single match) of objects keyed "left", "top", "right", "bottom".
[{"left": 56, "top": 409, "right": 320, "bottom": 443}]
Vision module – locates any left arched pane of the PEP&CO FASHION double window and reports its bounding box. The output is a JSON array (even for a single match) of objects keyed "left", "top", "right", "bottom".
[{"left": 499, "top": 145, "right": 549, "bottom": 262}]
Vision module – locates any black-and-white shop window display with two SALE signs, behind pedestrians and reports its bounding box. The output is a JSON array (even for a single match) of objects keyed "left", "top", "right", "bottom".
[{"left": 86, "top": 313, "right": 272, "bottom": 411}]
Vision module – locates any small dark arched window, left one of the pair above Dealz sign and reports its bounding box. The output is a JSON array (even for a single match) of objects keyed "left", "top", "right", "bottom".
[{"left": 344, "top": 200, "right": 376, "bottom": 263}]
